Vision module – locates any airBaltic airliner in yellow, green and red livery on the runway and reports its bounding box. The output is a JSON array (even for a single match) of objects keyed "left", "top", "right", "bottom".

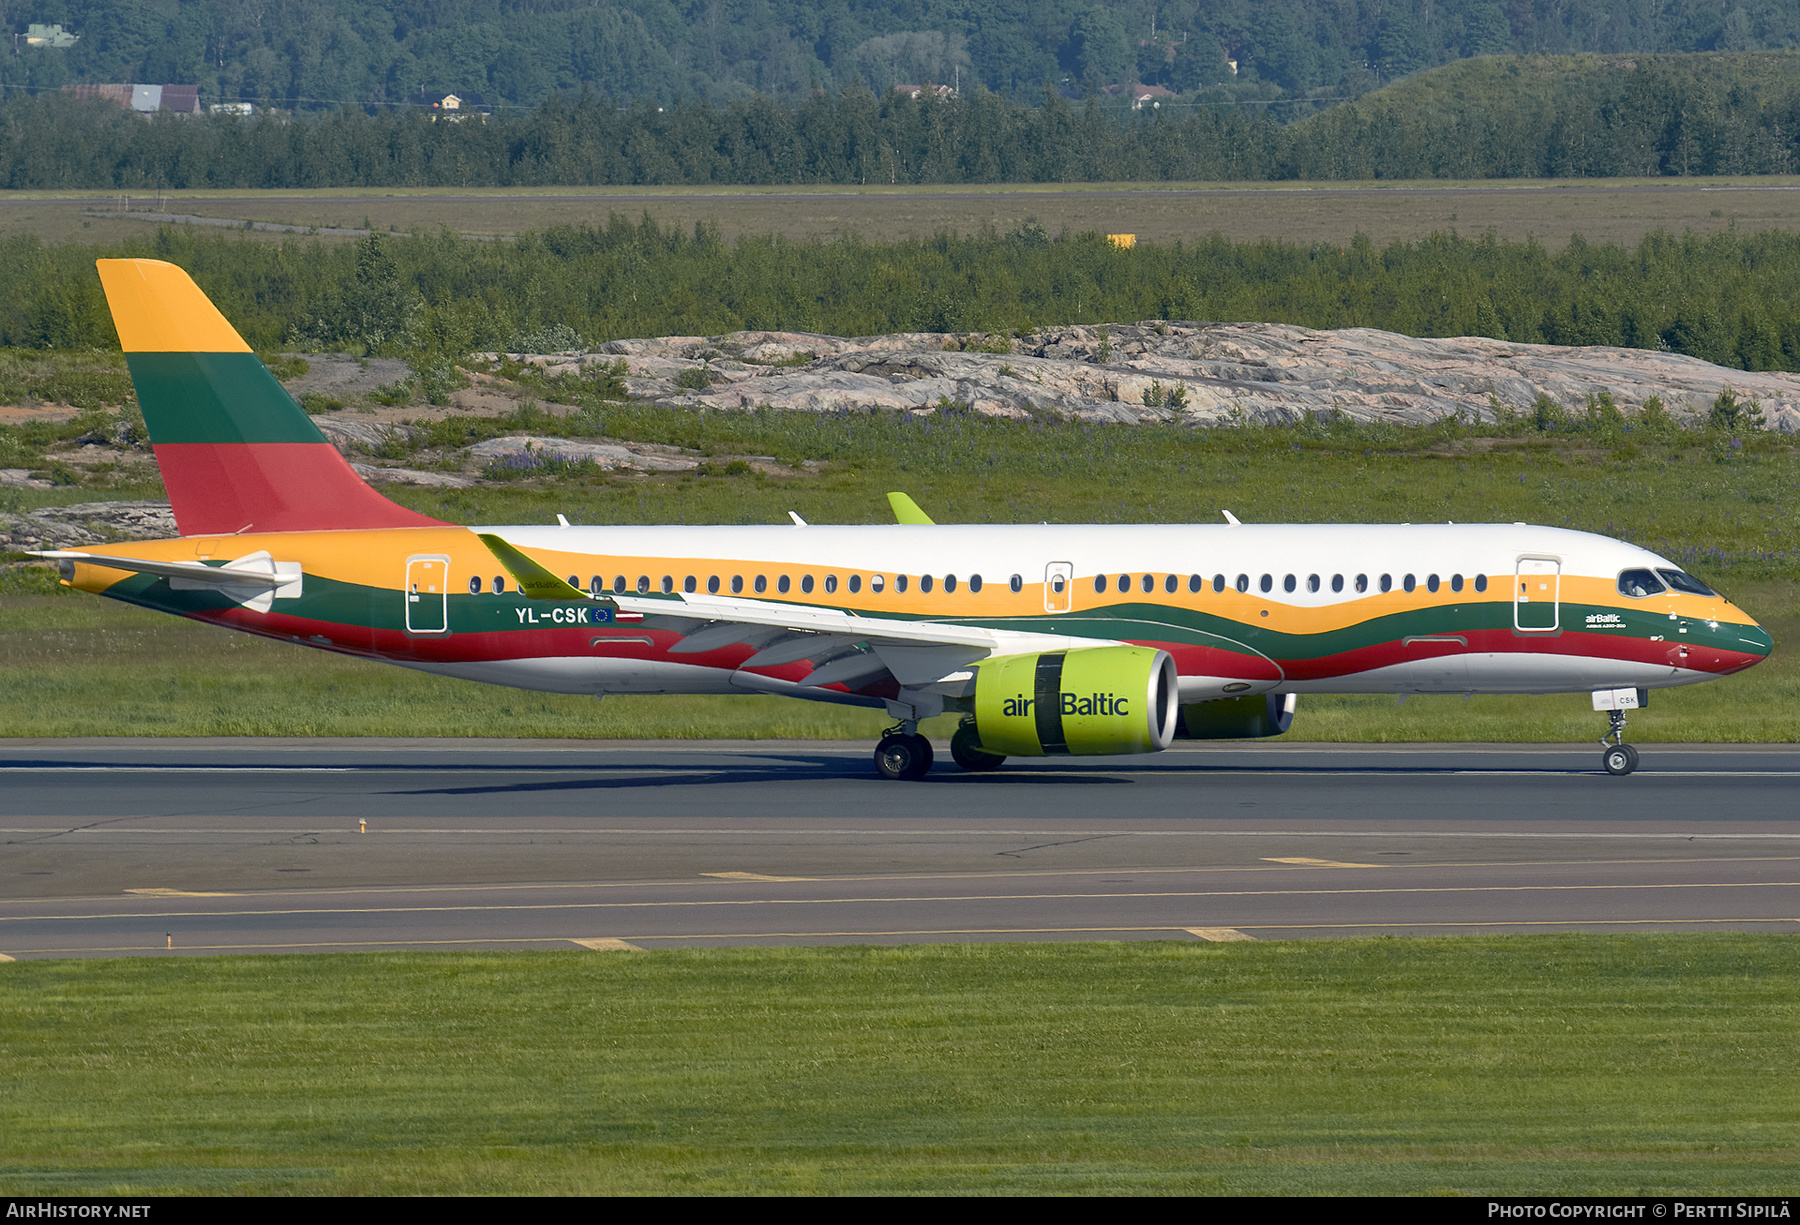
[{"left": 40, "top": 259, "right": 1773, "bottom": 779}]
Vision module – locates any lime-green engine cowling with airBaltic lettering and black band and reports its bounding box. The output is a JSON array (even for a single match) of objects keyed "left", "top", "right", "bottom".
[{"left": 976, "top": 646, "right": 1181, "bottom": 757}]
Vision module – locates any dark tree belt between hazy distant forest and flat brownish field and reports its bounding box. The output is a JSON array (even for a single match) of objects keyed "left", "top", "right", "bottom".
[{"left": 10, "top": 52, "right": 1800, "bottom": 192}]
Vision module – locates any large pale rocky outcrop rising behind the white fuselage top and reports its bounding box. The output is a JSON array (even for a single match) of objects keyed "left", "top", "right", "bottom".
[{"left": 488, "top": 322, "right": 1800, "bottom": 434}]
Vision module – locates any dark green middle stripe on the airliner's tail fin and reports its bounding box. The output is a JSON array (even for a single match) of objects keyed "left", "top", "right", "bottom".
[{"left": 124, "top": 353, "right": 326, "bottom": 444}]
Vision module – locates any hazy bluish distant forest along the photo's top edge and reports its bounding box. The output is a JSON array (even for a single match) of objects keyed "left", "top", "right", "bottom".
[{"left": 0, "top": 0, "right": 1800, "bottom": 112}]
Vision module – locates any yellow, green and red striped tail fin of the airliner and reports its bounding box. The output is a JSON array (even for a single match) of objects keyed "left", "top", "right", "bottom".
[{"left": 97, "top": 259, "right": 439, "bottom": 536}]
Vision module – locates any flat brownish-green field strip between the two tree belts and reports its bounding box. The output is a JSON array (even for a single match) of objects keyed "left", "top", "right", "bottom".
[{"left": 10, "top": 176, "right": 1800, "bottom": 248}]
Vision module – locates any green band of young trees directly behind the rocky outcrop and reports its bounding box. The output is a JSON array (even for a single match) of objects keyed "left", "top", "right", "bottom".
[{"left": 10, "top": 216, "right": 1800, "bottom": 372}]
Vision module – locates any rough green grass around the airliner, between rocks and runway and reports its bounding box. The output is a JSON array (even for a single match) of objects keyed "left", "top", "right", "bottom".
[{"left": 0, "top": 407, "right": 1800, "bottom": 741}]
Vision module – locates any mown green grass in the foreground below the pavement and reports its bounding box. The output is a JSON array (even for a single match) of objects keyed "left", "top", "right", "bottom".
[{"left": 0, "top": 934, "right": 1800, "bottom": 1194}]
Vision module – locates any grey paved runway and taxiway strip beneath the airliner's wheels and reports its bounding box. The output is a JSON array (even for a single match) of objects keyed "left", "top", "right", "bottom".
[{"left": 0, "top": 739, "right": 1800, "bottom": 959}]
